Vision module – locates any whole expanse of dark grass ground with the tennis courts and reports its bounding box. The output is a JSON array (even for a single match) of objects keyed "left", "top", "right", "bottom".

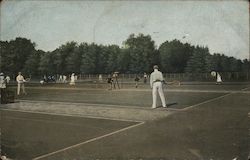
[{"left": 1, "top": 83, "right": 250, "bottom": 160}]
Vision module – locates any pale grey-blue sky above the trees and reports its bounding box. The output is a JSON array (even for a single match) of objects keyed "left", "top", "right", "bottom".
[{"left": 0, "top": 0, "right": 249, "bottom": 59}]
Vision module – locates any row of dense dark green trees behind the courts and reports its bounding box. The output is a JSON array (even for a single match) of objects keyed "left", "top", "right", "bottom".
[{"left": 0, "top": 34, "right": 250, "bottom": 76}]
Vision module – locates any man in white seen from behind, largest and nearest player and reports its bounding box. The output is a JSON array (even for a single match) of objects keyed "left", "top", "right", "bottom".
[{"left": 150, "top": 65, "right": 167, "bottom": 109}]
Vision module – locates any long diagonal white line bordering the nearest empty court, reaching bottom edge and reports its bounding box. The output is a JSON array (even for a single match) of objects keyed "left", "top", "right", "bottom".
[{"left": 33, "top": 122, "right": 144, "bottom": 160}]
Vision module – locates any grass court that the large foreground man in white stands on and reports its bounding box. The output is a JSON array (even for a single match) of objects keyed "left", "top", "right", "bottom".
[{"left": 7, "top": 84, "right": 248, "bottom": 108}]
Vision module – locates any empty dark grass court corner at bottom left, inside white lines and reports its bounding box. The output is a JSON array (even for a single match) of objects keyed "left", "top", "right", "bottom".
[{"left": 1, "top": 110, "right": 140, "bottom": 159}]
